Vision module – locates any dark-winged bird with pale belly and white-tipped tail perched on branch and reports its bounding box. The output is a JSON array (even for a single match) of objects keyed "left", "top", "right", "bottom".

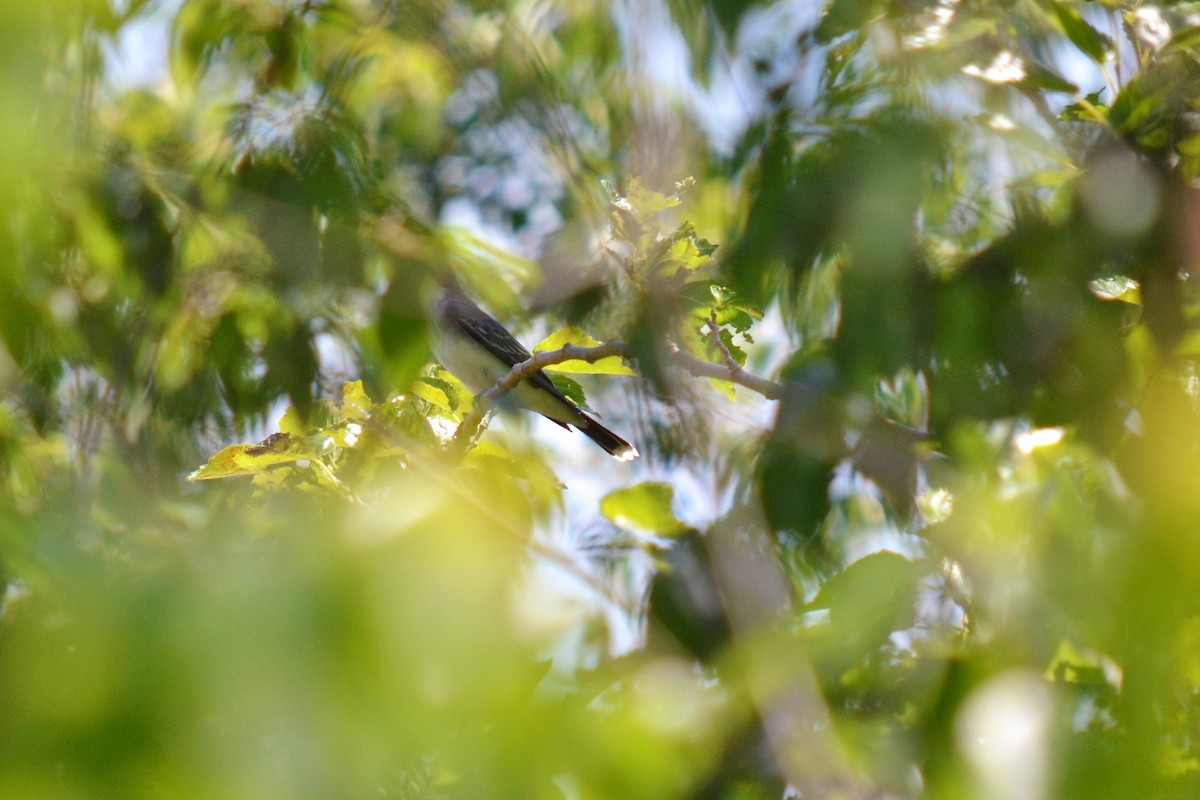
[{"left": 430, "top": 277, "right": 638, "bottom": 461}]
